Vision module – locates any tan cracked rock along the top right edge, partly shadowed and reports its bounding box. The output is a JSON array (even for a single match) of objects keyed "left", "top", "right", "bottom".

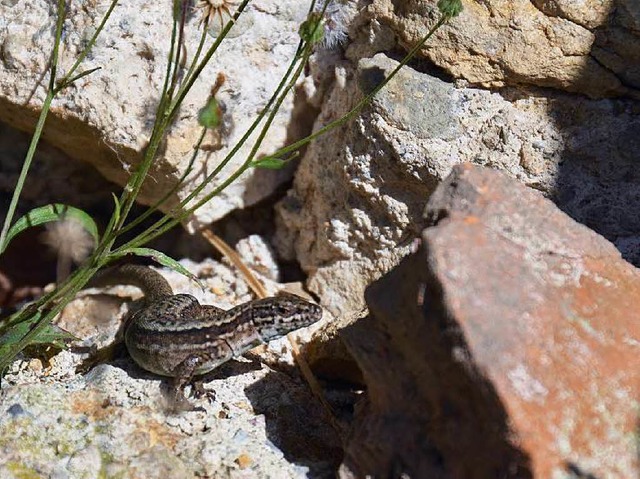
[{"left": 360, "top": 0, "right": 640, "bottom": 98}]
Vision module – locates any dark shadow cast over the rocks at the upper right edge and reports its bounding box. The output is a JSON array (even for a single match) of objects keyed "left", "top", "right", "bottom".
[{"left": 549, "top": 0, "right": 640, "bottom": 266}]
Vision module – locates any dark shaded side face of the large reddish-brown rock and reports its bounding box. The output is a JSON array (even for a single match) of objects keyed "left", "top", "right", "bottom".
[{"left": 341, "top": 249, "right": 533, "bottom": 479}]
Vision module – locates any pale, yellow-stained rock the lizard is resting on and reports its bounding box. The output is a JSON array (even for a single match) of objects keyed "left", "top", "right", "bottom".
[{"left": 0, "top": 261, "right": 341, "bottom": 479}]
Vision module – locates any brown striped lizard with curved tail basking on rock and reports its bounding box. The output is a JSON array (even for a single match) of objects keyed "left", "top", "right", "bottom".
[{"left": 91, "top": 264, "right": 322, "bottom": 399}]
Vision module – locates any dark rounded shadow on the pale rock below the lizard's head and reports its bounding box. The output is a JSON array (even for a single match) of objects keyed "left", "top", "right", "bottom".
[{"left": 245, "top": 370, "right": 343, "bottom": 479}]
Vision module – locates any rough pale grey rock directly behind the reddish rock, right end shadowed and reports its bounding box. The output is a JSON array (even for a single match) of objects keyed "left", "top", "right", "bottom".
[{"left": 278, "top": 50, "right": 640, "bottom": 312}]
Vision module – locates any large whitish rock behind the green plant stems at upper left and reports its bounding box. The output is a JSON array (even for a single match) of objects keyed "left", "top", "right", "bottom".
[{"left": 0, "top": 0, "right": 308, "bottom": 227}]
